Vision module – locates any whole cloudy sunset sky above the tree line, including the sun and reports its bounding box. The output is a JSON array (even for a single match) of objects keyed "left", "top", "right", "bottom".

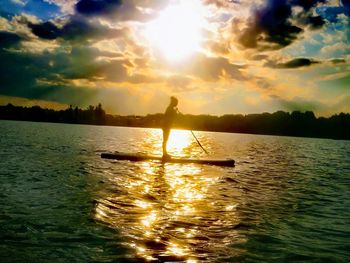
[{"left": 0, "top": 0, "right": 350, "bottom": 116}]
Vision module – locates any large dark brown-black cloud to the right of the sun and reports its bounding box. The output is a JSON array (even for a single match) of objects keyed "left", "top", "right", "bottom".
[{"left": 238, "top": 0, "right": 324, "bottom": 50}]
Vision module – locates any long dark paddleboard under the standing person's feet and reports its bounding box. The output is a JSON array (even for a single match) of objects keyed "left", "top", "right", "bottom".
[{"left": 101, "top": 152, "right": 235, "bottom": 167}]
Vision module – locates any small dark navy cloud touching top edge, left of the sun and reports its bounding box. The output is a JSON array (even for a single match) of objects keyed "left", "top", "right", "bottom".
[{"left": 75, "top": 0, "right": 122, "bottom": 16}]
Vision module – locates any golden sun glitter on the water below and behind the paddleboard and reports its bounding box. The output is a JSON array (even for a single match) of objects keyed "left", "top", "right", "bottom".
[{"left": 95, "top": 131, "right": 245, "bottom": 262}]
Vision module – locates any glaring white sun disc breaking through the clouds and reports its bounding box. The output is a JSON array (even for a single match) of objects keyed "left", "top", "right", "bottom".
[{"left": 145, "top": 0, "right": 205, "bottom": 61}]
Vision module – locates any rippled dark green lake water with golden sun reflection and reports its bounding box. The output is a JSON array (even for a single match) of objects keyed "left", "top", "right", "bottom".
[{"left": 0, "top": 121, "right": 350, "bottom": 262}]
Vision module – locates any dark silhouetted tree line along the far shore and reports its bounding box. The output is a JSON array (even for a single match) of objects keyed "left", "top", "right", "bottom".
[{"left": 0, "top": 104, "right": 350, "bottom": 140}]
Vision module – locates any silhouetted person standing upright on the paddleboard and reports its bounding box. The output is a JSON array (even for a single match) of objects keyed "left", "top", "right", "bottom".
[{"left": 162, "top": 96, "right": 178, "bottom": 158}]
